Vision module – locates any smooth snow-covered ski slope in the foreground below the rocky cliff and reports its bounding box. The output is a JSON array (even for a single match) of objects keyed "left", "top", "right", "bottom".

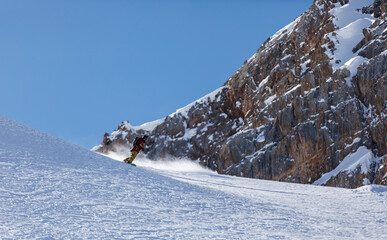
[{"left": 0, "top": 116, "right": 387, "bottom": 240}]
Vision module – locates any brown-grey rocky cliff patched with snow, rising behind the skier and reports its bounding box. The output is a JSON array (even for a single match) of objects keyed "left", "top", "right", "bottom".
[{"left": 93, "top": 0, "right": 387, "bottom": 188}]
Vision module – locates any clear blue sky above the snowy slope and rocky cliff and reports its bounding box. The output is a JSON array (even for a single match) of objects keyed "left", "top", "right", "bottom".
[{"left": 0, "top": 0, "right": 313, "bottom": 148}]
